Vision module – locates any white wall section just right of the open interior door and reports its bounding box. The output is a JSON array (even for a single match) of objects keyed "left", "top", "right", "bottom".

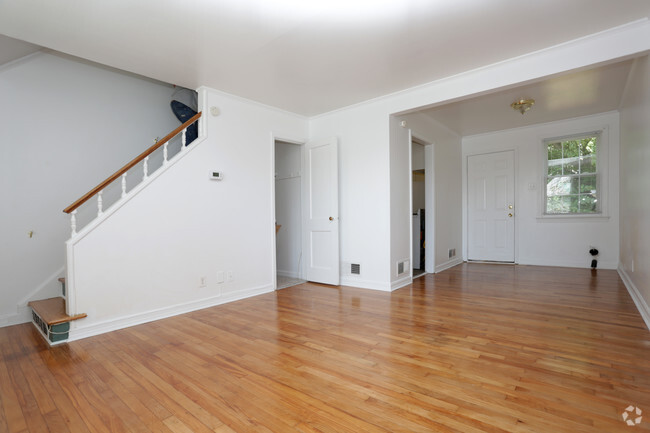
[{"left": 309, "top": 104, "right": 390, "bottom": 290}]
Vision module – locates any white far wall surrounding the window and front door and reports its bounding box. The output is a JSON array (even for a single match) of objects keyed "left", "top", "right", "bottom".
[{"left": 463, "top": 113, "right": 619, "bottom": 269}]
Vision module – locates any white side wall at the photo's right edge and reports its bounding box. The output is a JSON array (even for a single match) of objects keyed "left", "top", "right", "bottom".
[{"left": 619, "top": 56, "right": 650, "bottom": 328}]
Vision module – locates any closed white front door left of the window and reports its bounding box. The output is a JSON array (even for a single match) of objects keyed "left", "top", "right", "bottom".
[{"left": 467, "top": 150, "right": 515, "bottom": 262}]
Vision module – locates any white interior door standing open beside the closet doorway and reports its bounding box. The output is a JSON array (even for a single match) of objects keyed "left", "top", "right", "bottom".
[{"left": 302, "top": 138, "right": 339, "bottom": 285}]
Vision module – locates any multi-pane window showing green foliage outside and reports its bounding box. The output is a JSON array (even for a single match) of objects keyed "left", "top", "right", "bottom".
[{"left": 544, "top": 132, "right": 602, "bottom": 215}]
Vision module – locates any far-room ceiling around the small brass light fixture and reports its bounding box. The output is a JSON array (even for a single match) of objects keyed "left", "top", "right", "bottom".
[{"left": 420, "top": 60, "right": 634, "bottom": 137}]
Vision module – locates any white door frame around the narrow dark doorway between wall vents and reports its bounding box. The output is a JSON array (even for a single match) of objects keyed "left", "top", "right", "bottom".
[{"left": 408, "top": 129, "right": 436, "bottom": 280}]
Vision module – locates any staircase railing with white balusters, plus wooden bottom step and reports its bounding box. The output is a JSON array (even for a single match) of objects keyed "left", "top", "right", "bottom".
[{"left": 27, "top": 112, "right": 201, "bottom": 346}]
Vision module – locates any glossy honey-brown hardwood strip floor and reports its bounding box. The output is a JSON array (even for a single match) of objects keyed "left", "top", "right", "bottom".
[{"left": 0, "top": 264, "right": 650, "bottom": 433}]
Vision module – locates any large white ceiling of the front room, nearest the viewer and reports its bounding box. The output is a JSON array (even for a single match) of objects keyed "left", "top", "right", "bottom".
[{"left": 0, "top": 0, "right": 650, "bottom": 115}]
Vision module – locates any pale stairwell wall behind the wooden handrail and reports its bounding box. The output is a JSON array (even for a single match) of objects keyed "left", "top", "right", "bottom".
[{"left": 0, "top": 52, "right": 179, "bottom": 326}]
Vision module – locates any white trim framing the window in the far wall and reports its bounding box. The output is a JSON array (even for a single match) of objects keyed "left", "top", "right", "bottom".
[{"left": 537, "top": 126, "right": 609, "bottom": 222}]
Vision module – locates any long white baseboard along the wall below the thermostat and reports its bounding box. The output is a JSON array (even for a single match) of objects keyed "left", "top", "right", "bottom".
[{"left": 68, "top": 285, "right": 274, "bottom": 341}]
